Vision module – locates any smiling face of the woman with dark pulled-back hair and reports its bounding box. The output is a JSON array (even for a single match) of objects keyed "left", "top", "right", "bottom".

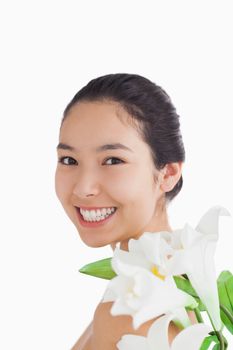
[{"left": 55, "top": 102, "right": 167, "bottom": 248}]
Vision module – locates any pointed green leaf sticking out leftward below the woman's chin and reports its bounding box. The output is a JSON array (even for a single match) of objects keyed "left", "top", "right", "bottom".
[{"left": 79, "top": 258, "right": 116, "bottom": 280}]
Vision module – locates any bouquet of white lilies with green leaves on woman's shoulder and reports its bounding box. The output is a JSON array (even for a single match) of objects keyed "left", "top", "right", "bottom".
[{"left": 79, "top": 206, "right": 233, "bottom": 350}]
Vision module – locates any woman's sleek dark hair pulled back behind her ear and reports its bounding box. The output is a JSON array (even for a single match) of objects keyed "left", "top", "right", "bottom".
[{"left": 61, "top": 73, "right": 185, "bottom": 202}]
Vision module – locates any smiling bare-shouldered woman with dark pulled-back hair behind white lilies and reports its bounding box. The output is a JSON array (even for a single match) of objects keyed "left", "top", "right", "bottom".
[{"left": 55, "top": 73, "right": 195, "bottom": 350}]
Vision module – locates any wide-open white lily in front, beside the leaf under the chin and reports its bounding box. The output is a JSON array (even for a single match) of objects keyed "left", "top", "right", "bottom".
[{"left": 102, "top": 251, "right": 197, "bottom": 329}]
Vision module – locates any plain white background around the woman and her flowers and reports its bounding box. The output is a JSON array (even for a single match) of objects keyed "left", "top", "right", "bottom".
[{"left": 0, "top": 0, "right": 233, "bottom": 350}]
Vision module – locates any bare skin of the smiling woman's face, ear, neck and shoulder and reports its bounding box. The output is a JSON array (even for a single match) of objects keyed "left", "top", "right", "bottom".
[{"left": 55, "top": 101, "right": 187, "bottom": 350}]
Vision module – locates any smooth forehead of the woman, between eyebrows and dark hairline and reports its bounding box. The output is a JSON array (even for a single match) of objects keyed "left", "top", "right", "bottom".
[{"left": 57, "top": 105, "right": 152, "bottom": 161}]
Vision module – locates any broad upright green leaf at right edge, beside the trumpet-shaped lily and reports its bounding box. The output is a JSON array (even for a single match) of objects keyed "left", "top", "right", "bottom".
[{"left": 217, "top": 271, "right": 233, "bottom": 334}]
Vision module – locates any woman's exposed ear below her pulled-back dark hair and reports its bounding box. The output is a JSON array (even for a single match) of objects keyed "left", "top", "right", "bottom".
[{"left": 160, "top": 162, "right": 183, "bottom": 192}]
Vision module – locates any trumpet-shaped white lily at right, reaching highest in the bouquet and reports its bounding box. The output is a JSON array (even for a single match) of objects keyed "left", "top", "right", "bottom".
[{"left": 159, "top": 206, "right": 230, "bottom": 330}]
